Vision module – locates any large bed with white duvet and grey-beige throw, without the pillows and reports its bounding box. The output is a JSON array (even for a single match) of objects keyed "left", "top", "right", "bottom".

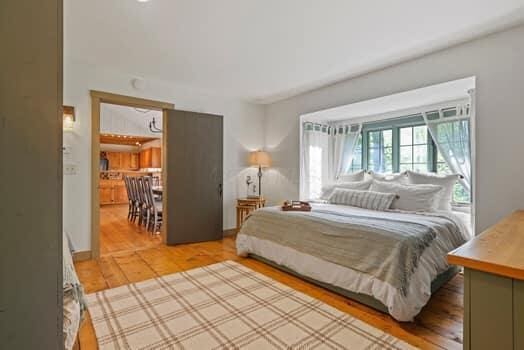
[{"left": 236, "top": 203, "right": 469, "bottom": 321}]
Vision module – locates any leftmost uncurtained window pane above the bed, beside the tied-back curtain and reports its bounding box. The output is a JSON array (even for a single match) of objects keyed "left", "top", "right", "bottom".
[{"left": 367, "top": 129, "right": 393, "bottom": 173}]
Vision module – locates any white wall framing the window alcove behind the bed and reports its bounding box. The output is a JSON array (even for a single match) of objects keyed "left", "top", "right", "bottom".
[{"left": 265, "top": 26, "right": 524, "bottom": 232}]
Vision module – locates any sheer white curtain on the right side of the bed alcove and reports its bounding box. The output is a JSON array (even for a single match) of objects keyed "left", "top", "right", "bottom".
[{"left": 423, "top": 92, "right": 474, "bottom": 192}]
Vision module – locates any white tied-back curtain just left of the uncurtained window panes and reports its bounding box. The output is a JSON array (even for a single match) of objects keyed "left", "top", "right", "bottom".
[{"left": 329, "top": 124, "right": 362, "bottom": 181}]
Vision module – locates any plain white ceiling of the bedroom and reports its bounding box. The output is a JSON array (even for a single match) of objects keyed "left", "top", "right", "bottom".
[{"left": 64, "top": 0, "right": 524, "bottom": 103}]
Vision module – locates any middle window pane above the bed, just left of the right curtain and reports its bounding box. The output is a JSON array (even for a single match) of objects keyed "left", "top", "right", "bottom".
[{"left": 399, "top": 125, "right": 431, "bottom": 172}]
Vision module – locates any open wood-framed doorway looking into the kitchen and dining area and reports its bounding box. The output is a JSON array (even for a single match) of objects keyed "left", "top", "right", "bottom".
[{"left": 91, "top": 91, "right": 174, "bottom": 258}]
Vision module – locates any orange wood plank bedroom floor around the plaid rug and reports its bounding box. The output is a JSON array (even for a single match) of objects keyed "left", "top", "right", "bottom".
[{"left": 75, "top": 209, "right": 463, "bottom": 350}]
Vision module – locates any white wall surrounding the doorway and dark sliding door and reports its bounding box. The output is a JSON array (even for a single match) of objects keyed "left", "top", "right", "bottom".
[{"left": 63, "top": 58, "right": 264, "bottom": 250}]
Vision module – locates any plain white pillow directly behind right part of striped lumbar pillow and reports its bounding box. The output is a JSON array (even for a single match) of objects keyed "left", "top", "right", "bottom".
[{"left": 369, "top": 180, "right": 442, "bottom": 211}]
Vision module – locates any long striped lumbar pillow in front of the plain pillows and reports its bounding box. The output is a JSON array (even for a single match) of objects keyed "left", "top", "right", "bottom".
[{"left": 329, "top": 188, "right": 397, "bottom": 211}]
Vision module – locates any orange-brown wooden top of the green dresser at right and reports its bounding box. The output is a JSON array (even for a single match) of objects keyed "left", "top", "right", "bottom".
[{"left": 448, "top": 210, "right": 524, "bottom": 280}]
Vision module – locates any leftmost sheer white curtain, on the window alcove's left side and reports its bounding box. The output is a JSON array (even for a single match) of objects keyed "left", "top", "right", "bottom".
[{"left": 300, "top": 122, "right": 332, "bottom": 199}]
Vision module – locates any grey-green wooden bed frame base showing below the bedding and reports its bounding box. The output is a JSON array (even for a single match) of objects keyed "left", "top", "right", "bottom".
[{"left": 249, "top": 254, "right": 460, "bottom": 314}]
